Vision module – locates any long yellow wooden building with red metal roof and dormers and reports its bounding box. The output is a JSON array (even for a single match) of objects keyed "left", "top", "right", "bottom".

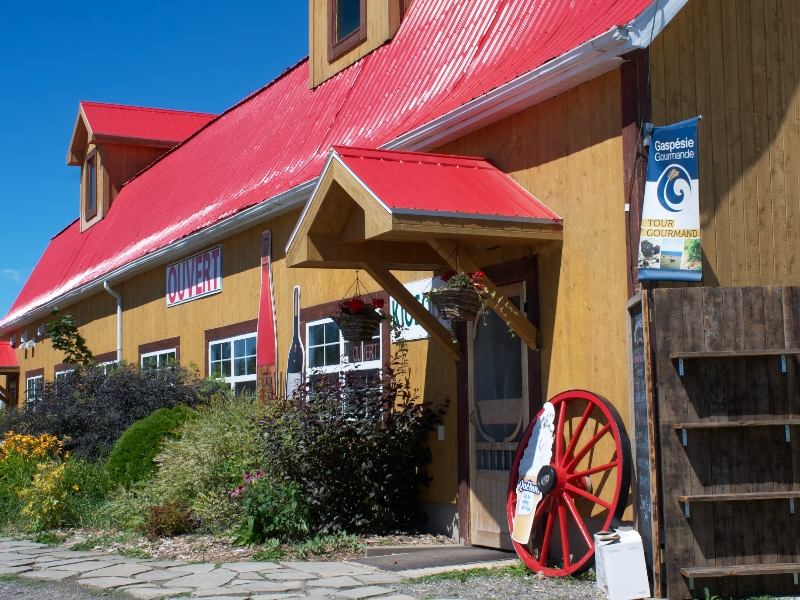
[{"left": 0, "top": 0, "right": 800, "bottom": 598}]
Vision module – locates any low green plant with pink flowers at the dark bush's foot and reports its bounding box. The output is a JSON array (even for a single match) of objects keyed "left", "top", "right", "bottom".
[{"left": 231, "top": 473, "right": 309, "bottom": 544}]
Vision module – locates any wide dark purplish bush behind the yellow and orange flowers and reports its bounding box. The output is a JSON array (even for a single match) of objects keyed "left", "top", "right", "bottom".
[{"left": 0, "top": 364, "right": 227, "bottom": 460}]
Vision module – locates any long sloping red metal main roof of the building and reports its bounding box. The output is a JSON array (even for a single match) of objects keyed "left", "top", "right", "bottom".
[{"left": 0, "top": 0, "right": 651, "bottom": 326}]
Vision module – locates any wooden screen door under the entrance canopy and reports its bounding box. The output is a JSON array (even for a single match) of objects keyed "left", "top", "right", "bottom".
[{"left": 467, "top": 283, "right": 529, "bottom": 550}]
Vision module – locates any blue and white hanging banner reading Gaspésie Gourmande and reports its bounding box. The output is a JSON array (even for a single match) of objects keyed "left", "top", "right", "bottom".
[{"left": 639, "top": 117, "right": 703, "bottom": 281}]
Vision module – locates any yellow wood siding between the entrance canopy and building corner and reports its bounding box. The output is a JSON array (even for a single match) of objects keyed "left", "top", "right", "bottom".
[{"left": 436, "top": 70, "right": 628, "bottom": 422}]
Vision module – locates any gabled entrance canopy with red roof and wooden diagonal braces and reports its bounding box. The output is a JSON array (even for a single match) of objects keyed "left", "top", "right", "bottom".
[{"left": 286, "top": 146, "right": 562, "bottom": 357}]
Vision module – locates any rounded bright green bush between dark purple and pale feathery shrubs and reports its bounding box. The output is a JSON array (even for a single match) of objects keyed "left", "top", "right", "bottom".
[{"left": 106, "top": 406, "right": 197, "bottom": 485}]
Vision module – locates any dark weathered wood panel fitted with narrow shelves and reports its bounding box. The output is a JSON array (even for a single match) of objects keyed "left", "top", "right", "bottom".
[{"left": 654, "top": 287, "right": 800, "bottom": 598}]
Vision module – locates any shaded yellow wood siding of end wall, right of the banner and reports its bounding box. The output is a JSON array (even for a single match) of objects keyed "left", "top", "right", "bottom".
[{"left": 651, "top": 0, "right": 800, "bottom": 286}]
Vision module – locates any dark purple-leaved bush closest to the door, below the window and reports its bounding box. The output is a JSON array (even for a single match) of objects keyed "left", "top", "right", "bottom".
[{"left": 261, "top": 353, "right": 446, "bottom": 532}]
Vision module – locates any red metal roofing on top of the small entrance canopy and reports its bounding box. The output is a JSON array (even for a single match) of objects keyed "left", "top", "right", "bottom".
[{"left": 333, "top": 146, "right": 561, "bottom": 224}]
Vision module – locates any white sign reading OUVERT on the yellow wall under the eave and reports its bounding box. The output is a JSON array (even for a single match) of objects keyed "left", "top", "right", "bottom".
[{"left": 167, "top": 246, "right": 222, "bottom": 307}]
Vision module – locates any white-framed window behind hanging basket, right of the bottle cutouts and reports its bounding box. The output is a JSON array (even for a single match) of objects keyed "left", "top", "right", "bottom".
[{"left": 306, "top": 319, "right": 382, "bottom": 380}]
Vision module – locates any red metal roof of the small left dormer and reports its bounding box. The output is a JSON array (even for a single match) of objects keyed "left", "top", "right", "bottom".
[{"left": 80, "top": 102, "right": 217, "bottom": 143}]
